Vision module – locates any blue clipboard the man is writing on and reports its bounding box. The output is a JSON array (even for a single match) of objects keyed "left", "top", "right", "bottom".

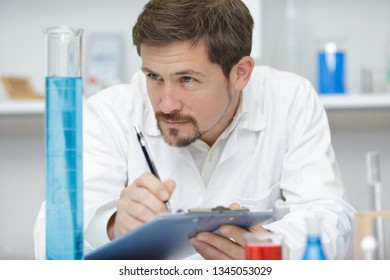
[{"left": 85, "top": 206, "right": 273, "bottom": 260}]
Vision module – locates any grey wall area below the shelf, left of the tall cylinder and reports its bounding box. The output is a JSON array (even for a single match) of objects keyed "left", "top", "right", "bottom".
[{"left": 0, "top": 115, "right": 45, "bottom": 259}]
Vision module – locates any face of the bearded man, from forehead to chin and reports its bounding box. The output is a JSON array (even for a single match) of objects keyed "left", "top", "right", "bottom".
[{"left": 141, "top": 42, "right": 239, "bottom": 147}]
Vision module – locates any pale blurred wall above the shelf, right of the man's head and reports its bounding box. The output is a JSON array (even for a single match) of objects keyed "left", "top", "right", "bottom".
[{"left": 262, "top": 0, "right": 390, "bottom": 92}]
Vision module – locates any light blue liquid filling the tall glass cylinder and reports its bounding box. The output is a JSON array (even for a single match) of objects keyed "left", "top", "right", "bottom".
[{"left": 45, "top": 77, "right": 83, "bottom": 260}]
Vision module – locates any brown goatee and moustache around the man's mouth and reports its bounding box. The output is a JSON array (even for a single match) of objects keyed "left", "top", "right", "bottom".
[{"left": 155, "top": 112, "right": 207, "bottom": 148}]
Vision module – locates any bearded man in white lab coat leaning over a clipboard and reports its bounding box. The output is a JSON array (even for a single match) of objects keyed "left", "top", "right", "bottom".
[{"left": 35, "top": 0, "right": 354, "bottom": 259}]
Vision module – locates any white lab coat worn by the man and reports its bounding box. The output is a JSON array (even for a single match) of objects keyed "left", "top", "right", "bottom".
[{"left": 34, "top": 67, "right": 354, "bottom": 259}]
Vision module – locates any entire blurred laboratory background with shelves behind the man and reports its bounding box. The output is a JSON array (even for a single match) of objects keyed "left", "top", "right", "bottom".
[{"left": 0, "top": 0, "right": 390, "bottom": 259}]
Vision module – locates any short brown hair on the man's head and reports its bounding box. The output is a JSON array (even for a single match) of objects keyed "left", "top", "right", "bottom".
[{"left": 133, "top": 0, "right": 254, "bottom": 78}]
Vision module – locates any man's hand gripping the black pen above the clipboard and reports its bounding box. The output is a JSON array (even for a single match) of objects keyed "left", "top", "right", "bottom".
[{"left": 107, "top": 173, "right": 176, "bottom": 240}]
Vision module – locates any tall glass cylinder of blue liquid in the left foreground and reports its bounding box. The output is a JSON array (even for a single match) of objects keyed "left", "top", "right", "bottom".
[{"left": 44, "top": 27, "right": 83, "bottom": 260}]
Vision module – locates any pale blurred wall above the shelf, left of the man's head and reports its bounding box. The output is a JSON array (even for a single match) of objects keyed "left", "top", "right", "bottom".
[{"left": 0, "top": 0, "right": 147, "bottom": 93}]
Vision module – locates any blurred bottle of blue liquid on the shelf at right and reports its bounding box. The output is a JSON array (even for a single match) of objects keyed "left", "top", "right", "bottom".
[{"left": 317, "top": 42, "right": 345, "bottom": 94}]
